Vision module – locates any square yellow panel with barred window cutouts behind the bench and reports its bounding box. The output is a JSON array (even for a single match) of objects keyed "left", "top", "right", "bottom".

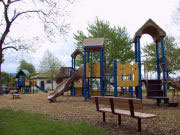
[{"left": 117, "top": 62, "right": 139, "bottom": 87}]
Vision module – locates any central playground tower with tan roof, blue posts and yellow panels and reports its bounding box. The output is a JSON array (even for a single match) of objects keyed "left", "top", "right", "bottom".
[{"left": 83, "top": 38, "right": 104, "bottom": 101}]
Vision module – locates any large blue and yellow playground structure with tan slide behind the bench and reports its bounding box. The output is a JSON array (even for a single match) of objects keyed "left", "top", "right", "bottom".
[{"left": 48, "top": 19, "right": 179, "bottom": 104}]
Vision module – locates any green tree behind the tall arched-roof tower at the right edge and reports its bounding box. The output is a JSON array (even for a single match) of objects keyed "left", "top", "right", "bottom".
[{"left": 143, "top": 36, "right": 180, "bottom": 74}]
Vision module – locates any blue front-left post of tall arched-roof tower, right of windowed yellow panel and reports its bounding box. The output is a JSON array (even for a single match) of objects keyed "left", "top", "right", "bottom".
[{"left": 137, "top": 37, "right": 142, "bottom": 100}]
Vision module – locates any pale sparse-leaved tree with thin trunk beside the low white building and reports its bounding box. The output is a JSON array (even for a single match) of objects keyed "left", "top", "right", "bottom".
[{"left": 40, "top": 50, "right": 62, "bottom": 89}]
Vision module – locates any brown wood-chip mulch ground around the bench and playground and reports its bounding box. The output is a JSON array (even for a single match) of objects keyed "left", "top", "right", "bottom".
[{"left": 0, "top": 92, "right": 180, "bottom": 135}]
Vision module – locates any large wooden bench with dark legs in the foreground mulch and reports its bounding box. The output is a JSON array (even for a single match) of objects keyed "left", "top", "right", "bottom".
[{"left": 92, "top": 96, "right": 157, "bottom": 132}]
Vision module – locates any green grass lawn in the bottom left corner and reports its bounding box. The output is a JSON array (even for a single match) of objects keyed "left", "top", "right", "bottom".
[{"left": 0, "top": 109, "right": 109, "bottom": 135}]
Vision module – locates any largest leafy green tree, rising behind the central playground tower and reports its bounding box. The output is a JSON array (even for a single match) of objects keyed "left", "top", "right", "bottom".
[{"left": 74, "top": 18, "right": 134, "bottom": 71}]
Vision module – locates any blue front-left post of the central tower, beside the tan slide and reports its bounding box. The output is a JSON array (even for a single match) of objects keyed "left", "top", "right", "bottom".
[{"left": 83, "top": 49, "right": 87, "bottom": 101}]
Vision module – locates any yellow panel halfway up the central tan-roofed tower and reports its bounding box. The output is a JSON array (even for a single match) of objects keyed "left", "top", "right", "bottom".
[{"left": 86, "top": 62, "right": 101, "bottom": 78}]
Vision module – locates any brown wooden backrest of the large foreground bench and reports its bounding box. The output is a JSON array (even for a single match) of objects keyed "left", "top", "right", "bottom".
[{"left": 92, "top": 96, "right": 142, "bottom": 117}]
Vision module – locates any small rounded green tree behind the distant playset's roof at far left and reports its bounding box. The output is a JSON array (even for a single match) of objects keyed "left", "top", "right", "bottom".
[{"left": 17, "top": 60, "right": 36, "bottom": 74}]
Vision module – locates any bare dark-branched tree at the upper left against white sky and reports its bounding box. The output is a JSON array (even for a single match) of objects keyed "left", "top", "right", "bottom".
[{"left": 0, "top": 0, "right": 74, "bottom": 94}]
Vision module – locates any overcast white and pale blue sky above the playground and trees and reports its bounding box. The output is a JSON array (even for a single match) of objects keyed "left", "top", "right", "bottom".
[{"left": 2, "top": 0, "right": 180, "bottom": 75}]
